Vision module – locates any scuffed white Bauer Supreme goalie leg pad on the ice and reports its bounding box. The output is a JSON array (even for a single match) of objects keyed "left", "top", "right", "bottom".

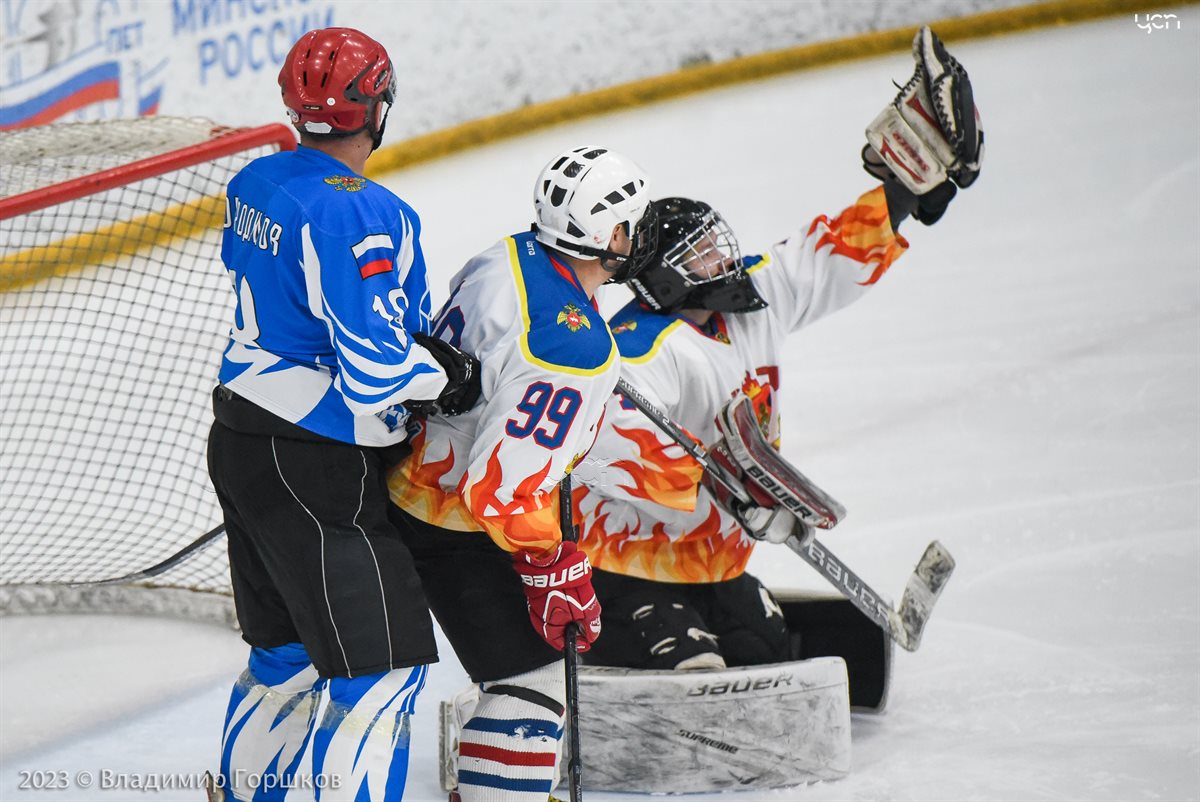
[{"left": 580, "top": 657, "right": 850, "bottom": 798}]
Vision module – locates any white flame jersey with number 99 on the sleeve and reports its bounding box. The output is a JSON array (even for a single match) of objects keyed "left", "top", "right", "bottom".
[{"left": 389, "top": 233, "right": 620, "bottom": 552}]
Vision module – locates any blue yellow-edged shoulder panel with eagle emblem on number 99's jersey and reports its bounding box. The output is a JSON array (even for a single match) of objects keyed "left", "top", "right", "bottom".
[{"left": 502, "top": 232, "right": 617, "bottom": 375}]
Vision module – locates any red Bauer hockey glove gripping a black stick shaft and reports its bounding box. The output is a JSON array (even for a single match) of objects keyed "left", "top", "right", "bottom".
[{"left": 512, "top": 541, "right": 600, "bottom": 652}]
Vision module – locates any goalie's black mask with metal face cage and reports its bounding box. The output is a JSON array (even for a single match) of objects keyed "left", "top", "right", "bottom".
[{"left": 629, "top": 198, "right": 767, "bottom": 312}]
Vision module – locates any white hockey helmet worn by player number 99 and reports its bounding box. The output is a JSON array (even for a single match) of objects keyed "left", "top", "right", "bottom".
[{"left": 533, "top": 146, "right": 654, "bottom": 281}]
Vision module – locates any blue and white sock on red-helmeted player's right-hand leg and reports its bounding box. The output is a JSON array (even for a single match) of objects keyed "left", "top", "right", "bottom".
[{"left": 304, "top": 665, "right": 428, "bottom": 802}]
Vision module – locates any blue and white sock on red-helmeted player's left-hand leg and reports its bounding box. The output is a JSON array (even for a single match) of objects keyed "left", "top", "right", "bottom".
[{"left": 220, "top": 644, "right": 318, "bottom": 802}]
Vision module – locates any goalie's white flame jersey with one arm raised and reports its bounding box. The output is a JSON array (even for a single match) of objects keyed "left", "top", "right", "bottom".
[{"left": 575, "top": 187, "right": 907, "bottom": 582}]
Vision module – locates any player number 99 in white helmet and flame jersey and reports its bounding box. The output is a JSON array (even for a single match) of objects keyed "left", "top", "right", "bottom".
[{"left": 389, "top": 146, "right": 653, "bottom": 802}]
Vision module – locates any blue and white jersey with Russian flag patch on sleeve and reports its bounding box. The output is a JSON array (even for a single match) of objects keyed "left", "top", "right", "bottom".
[{"left": 220, "top": 146, "right": 446, "bottom": 445}]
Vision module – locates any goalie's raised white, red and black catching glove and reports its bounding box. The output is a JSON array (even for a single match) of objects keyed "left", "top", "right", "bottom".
[{"left": 863, "top": 28, "right": 983, "bottom": 226}]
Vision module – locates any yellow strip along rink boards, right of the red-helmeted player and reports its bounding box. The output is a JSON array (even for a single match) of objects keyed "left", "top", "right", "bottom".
[{"left": 366, "top": 0, "right": 1195, "bottom": 178}]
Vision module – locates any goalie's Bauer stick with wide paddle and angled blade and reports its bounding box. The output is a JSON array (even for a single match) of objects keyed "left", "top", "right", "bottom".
[{"left": 617, "top": 378, "right": 954, "bottom": 652}]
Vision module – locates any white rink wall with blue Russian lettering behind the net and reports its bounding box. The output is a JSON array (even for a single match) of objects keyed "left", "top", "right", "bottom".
[{"left": 0, "top": 0, "right": 1028, "bottom": 136}]
